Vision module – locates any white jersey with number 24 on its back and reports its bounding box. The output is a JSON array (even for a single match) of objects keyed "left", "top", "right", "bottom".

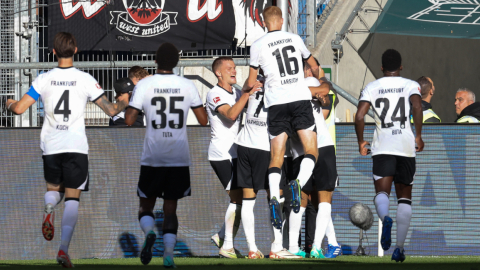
[{"left": 359, "top": 77, "right": 420, "bottom": 157}]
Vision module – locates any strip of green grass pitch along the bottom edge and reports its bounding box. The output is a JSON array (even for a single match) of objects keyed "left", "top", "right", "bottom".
[{"left": 0, "top": 256, "right": 480, "bottom": 270}]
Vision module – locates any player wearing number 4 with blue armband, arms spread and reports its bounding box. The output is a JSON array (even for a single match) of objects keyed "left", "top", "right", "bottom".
[{"left": 6, "top": 32, "right": 128, "bottom": 268}]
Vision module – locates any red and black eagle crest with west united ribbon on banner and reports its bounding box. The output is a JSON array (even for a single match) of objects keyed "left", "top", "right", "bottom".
[{"left": 110, "top": 0, "right": 178, "bottom": 37}]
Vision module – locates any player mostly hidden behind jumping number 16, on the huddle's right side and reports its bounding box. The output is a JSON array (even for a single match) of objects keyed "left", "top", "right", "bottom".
[{"left": 289, "top": 60, "right": 341, "bottom": 258}]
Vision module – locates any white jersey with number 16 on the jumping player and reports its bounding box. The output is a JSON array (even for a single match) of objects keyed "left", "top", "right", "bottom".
[{"left": 250, "top": 31, "right": 312, "bottom": 108}]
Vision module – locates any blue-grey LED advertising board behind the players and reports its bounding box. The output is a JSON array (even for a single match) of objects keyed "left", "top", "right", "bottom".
[{"left": 0, "top": 124, "right": 480, "bottom": 260}]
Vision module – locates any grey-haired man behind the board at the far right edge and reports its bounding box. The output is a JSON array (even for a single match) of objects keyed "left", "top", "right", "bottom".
[{"left": 455, "top": 88, "right": 480, "bottom": 123}]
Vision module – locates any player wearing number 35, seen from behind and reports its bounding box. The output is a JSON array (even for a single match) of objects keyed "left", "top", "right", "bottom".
[{"left": 125, "top": 43, "right": 208, "bottom": 268}]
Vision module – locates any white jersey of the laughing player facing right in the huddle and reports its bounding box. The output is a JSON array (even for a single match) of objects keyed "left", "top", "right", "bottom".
[{"left": 207, "top": 85, "right": 242, "bottom": 160}]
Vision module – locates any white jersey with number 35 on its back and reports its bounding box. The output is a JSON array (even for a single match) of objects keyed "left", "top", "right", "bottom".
[{"left": 129, "top": 74, "right": 203, "bottom": 167}]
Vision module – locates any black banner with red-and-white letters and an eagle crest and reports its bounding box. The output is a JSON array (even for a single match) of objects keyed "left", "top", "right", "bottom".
[{"left": 48, "top": 0, "right": 235, "bottom": 51}]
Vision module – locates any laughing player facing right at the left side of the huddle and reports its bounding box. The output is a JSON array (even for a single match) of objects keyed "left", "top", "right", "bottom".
[{"left": 206, "top": 57, "right": 261, "bottom": 259}]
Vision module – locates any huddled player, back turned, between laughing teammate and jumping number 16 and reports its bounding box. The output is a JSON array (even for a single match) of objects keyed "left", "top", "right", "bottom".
[{"left": 235, "top": 71, "right": 300, "bottom": 259}]
